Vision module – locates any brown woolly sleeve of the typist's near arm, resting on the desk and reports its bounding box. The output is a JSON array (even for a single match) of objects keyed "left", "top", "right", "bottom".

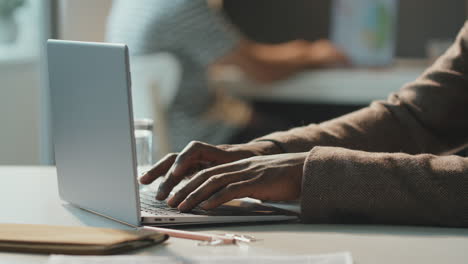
[{"left": 301, "top": 147, "right": 468, "bottom": 227}]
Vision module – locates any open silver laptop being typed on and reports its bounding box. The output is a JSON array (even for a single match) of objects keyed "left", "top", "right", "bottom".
[{"left": 47, "top": 40, "right": 297, "bottom": 226}]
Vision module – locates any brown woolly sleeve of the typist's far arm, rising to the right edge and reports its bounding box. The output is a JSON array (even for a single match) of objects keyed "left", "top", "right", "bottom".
[{"left": 254, "top": 24, "right": 468, "bottom": 154}]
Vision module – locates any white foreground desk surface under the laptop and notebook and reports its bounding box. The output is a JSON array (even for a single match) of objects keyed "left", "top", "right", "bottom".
[{"left": 0, "top": 167, "right": 468, "bottom": 264}]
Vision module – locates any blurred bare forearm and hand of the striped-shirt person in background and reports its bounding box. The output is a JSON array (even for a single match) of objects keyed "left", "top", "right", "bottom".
[{"left": 210, "top": 39, "right": 350, "bottom": 83}]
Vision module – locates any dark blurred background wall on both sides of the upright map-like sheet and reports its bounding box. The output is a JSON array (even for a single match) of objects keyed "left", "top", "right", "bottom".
[{"left": 224, "top": 0, "right": 467, "bottom": 57}]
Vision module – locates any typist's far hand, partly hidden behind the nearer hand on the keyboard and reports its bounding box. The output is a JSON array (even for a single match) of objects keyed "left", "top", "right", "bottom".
[{"left": 140, "top": 141, "right": 278, "bottom": 200}]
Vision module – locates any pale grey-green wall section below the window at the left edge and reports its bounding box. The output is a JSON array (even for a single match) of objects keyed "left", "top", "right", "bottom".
[{"left": 0, "top": 61, "right": 40, "bottom": 164}]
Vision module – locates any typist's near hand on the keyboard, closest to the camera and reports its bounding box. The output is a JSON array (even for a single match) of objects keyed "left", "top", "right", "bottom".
[{"left": 168, "top": 152, "right": 307, "bottom": 212}]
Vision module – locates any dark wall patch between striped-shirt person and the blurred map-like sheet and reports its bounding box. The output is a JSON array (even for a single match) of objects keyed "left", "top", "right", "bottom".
[{"left": 224, "top": 0, "right": 331, "bottom": 43}]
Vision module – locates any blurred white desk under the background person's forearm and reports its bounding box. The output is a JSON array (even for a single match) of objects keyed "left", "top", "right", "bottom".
[{"left": 211, "top": 60, "right": 428, "bottom": 105}]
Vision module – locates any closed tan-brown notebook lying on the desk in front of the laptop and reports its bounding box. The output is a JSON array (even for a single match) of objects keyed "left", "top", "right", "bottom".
[{"left": 0, "top": 224, "right": 168, "bottom": 255}]
